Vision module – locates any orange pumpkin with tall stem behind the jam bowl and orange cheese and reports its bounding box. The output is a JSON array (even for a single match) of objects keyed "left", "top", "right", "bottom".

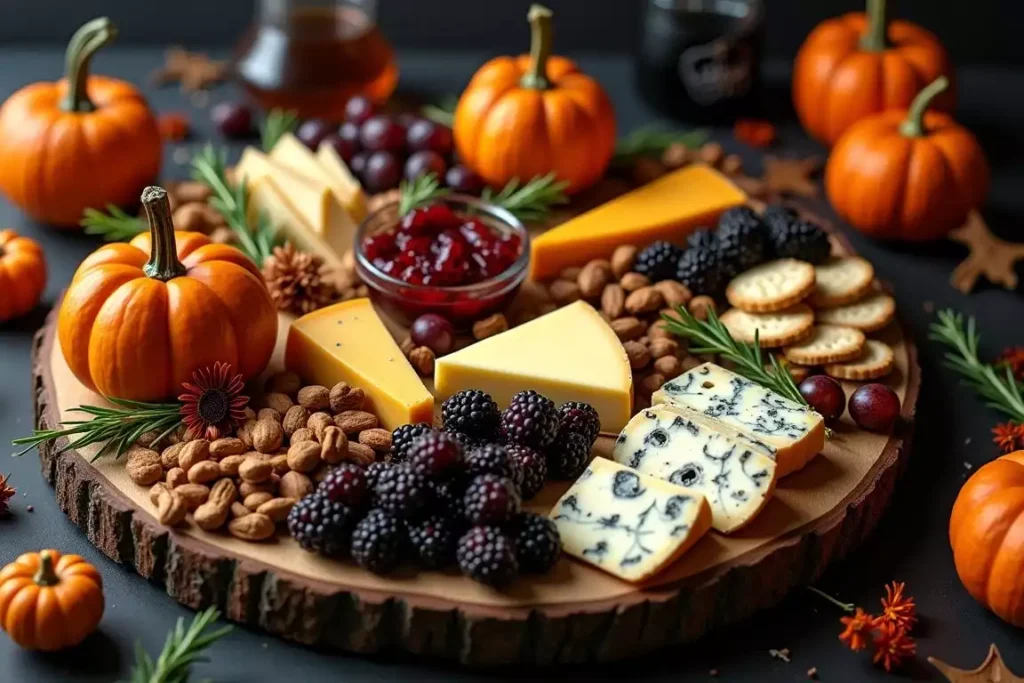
[{"left": 453, "top": 5, "right": 615, "bottom": 193}]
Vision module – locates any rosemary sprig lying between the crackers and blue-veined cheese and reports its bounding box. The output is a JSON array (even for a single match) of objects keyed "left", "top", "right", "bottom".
[{"left": 662, "top": 306, "right": 808, "bottom": 405}]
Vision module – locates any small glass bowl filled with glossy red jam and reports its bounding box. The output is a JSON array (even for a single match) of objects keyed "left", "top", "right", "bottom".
[{"left": 355, "top": 195, "right": 529, "bottom": 329}]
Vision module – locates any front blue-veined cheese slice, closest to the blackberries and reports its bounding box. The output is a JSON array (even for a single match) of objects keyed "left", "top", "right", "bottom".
[{"left": 551, "top": 458, "right": 711, "bottom": 583}]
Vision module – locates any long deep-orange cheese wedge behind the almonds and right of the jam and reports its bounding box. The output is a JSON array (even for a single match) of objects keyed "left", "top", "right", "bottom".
[{"left": 529, "top": 164, "right": 746, "bottom": 280}]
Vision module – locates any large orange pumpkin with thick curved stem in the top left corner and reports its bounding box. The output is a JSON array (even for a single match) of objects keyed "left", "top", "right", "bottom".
[{"left": 0, "top": 18, "right": 162, "bottom": 226}]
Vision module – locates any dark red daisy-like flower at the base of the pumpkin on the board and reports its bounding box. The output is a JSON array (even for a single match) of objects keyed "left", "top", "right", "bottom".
[{"left": 178, "top": 361, "right": 249, "bottom": 441}]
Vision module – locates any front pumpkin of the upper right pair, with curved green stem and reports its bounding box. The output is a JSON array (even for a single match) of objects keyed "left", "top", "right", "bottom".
[{"left": 825, "top": 77, "right": 988, "bottom": 241}]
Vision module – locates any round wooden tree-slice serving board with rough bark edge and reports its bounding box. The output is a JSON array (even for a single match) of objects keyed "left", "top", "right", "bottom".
[{"left": 33, "top": 245, "right": 920, "bottom": 666}]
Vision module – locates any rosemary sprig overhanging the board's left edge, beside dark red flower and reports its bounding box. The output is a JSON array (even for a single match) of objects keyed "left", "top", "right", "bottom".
[{"left": 11, "top": 398, "right": 181, "bottom": 460}]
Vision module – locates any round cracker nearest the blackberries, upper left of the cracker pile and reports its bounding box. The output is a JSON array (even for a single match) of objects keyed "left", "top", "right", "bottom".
[{"left": 725, "top": 258, "right": 814, "bottom": 313}]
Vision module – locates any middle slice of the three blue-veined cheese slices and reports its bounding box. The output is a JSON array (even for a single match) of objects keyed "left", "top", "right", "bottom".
[{"left": 612, "top": 403, "right": 775, "bottom": 533}]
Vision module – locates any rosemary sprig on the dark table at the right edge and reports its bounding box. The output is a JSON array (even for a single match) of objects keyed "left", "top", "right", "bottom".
[{"left": 929, "top": 308, "right": 1024, "bottom": 423}]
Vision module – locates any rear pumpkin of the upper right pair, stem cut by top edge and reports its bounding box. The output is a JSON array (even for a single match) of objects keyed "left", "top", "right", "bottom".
[{"left": 793, "top": 0, "right": 954, "bottom": 144}]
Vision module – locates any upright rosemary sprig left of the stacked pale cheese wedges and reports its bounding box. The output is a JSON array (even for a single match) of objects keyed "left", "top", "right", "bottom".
[{"left": 191, "top": 144, "right": 279, "bottom": 265}]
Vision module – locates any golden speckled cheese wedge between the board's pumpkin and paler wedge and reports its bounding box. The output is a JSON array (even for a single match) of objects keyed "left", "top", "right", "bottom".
[{"left": 285, "top": 299, "right": 434, "bottom": 429}]
